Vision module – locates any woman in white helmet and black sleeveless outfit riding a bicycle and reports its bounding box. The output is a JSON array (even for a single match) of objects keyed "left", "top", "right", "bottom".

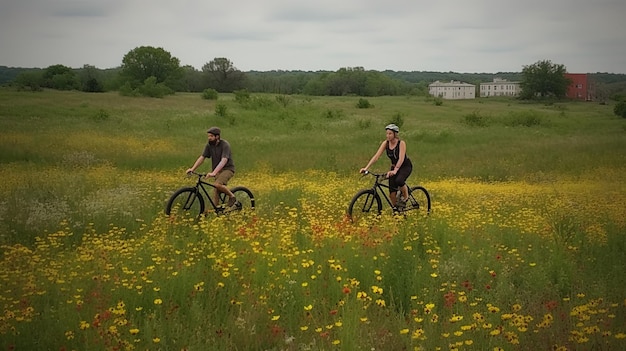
[{"left": 360, "top": 124, "right": 413, "bottom": 207}]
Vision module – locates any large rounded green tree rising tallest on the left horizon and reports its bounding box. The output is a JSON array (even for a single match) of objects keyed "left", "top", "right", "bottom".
[{"left": 121, "top": 46, "right": 183, "bottom": 89}]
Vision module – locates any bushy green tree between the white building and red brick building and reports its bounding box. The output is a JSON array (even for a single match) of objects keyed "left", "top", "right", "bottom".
[{"left": 520, "top": 60, "right": 571, "bottom": 99}]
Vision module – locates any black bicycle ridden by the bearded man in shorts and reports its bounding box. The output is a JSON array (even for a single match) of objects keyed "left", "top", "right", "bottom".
[{"left": 165, "top": 172, "right": 254, "bottom": 220}]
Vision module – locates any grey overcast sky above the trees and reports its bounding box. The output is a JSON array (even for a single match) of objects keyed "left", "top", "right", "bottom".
[{"left": 0, "top": 0, "right": 626, "bottom": 73}]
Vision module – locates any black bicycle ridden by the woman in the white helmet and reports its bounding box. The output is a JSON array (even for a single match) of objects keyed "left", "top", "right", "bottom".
[{"left": 348, "top": 171, "right": 431, "bottom": 223}]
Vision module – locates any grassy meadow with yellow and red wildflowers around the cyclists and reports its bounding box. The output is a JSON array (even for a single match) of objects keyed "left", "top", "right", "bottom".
[{"left": 0, "top": 90, "right": 626, "bottom": 351}]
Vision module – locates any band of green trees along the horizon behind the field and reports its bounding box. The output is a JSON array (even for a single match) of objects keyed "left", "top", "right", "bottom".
[{"left": 0, "top": 46, "right": 626, "bottom": 100}]
